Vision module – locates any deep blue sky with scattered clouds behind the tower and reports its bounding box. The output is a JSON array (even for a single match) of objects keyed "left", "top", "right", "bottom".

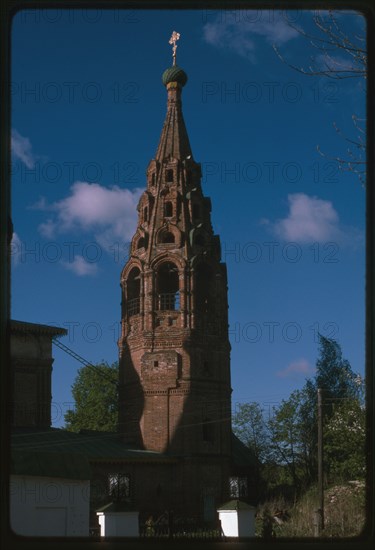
[{"left": 11, "top": 10, "right": 366, "bottom": 426}]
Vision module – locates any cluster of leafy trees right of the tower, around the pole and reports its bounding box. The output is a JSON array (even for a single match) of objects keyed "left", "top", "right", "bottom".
[{"left": 233, "top": 334, "right": 365, "bottom": 491}]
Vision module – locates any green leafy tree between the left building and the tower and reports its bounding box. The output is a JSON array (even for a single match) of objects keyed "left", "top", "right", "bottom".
[{"left": 65, "top": 362, "right": 118, "bottom": 432}]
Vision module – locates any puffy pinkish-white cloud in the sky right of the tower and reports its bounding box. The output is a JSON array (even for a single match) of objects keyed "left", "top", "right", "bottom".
[{"left": 262, "top": 193, "right": 342, "bottom": 243}]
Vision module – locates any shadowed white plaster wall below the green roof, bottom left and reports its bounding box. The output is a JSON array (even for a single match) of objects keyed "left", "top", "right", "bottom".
[{"left": 10, "top": 475, "right": 90, "bottom": 537}]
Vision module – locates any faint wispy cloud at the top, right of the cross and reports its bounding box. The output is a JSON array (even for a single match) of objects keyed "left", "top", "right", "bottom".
[{"left": 203, "top": 10, "right": 299, "bottom": 62}]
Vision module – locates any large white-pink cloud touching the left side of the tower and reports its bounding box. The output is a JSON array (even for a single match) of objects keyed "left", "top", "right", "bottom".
[{"left": 33, "top": 181, "right": 143, "bottom": 248}]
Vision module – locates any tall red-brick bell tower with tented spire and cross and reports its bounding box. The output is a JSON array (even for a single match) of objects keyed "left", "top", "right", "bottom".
[{"left": 118, "top": 33, "right": 231, "bottom": 498}]
